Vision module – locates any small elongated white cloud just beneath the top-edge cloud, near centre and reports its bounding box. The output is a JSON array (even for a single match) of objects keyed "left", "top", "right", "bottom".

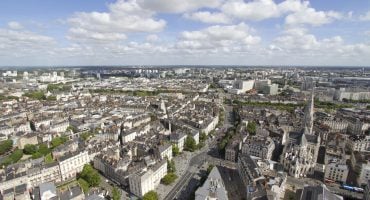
[{"left": 184, "top": 11, "right": 231, "bottom": 24}]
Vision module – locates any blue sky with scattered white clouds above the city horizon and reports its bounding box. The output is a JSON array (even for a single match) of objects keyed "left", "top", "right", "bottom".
[{"left": 0, "top": 0, "right": 370, "bottom": 66}]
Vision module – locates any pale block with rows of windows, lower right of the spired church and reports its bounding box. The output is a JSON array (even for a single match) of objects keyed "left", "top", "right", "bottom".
[{"left": 325, "top": 162, "right": 349, "bottom": 183}]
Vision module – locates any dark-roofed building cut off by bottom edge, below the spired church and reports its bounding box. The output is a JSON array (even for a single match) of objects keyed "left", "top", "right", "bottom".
[{"left": 299, "top": 185, "right": 343, "bottom": 200}]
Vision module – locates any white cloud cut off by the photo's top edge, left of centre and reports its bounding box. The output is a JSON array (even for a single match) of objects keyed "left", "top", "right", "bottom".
[{"left": 138, "top": 0, "right": 222, "bottom": 13}]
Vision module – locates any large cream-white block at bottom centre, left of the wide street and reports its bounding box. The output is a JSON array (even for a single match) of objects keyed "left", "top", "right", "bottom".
[{"left": 129, "top": 160, "right": 167, "bottom": 197}]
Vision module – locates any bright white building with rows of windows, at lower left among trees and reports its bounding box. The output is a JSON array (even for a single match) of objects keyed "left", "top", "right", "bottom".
[{"left": 58, "top": 151, "right": 90, "bottom": 181}]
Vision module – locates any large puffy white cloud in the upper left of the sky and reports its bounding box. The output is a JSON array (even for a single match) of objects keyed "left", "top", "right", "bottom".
[{"left": 68, "top": 0, "right": 166, "bottom": 41}]
